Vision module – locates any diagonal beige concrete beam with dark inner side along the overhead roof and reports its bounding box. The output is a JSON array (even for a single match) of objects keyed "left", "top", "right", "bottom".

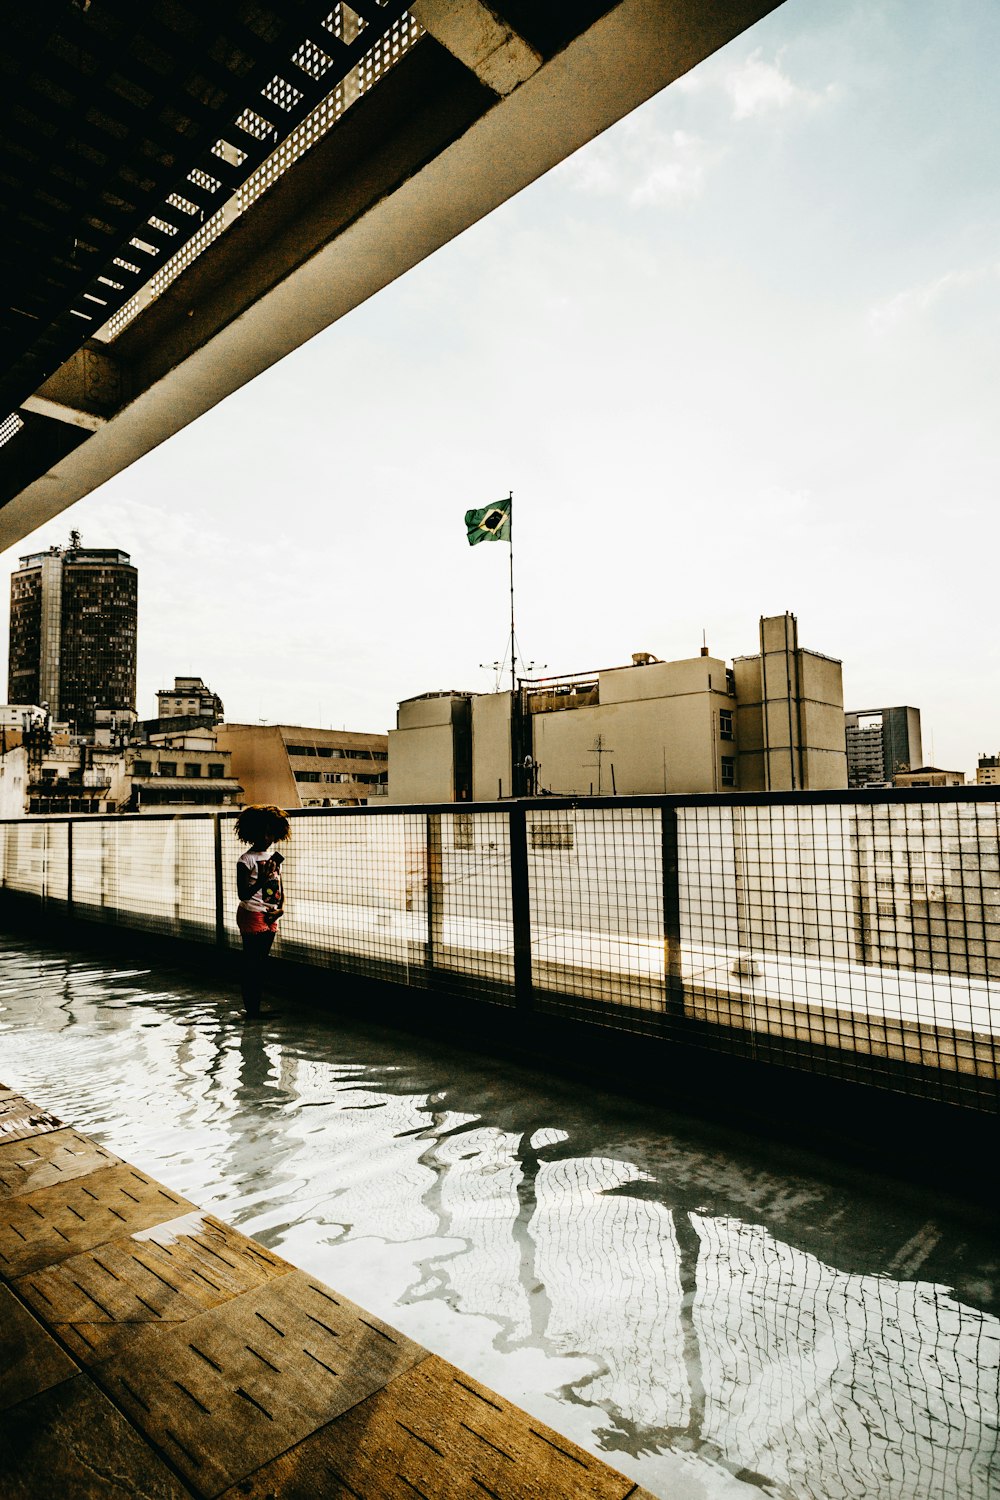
[{"left": 0, "top": 0, "right": 781, "bottom": 548}]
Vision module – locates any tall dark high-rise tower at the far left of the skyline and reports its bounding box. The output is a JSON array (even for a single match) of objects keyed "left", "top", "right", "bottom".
[{"left": 7, "top": 533, "right": 138, "bottom": 734}]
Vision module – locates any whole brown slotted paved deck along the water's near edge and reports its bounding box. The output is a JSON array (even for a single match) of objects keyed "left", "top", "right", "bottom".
[{"left": 0, "top": 1086, "right": 652, "bottom": 1500}]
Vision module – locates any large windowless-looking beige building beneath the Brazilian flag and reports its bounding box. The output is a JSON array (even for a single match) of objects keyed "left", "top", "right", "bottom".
[{"left": 388, "top": 615, "right": 847, "bottom": 804}]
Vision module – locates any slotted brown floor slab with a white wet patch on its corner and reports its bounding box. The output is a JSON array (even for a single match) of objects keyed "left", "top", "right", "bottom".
[{"left": 15, "top": 1212, "right": 292, "bottom": 1365}]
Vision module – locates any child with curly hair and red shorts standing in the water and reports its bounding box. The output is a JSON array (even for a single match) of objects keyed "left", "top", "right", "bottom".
[{"left": 235, "top": 804, "right": 291, "bottom": 1020}]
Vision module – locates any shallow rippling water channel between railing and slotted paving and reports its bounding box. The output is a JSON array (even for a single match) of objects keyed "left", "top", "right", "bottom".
[{"left": 0, "top": 936, "right": 1000, "bottom": 1500}]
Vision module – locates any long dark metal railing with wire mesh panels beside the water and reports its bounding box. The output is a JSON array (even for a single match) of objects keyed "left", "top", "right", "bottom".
[{"left": 0, "top": 788, "right": 1000, "bottom": 1113}]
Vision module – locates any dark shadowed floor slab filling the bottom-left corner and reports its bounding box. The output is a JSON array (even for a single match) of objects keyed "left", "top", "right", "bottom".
[{"left": 0, "top": 1374, "right": 189, "bottom": 1500}]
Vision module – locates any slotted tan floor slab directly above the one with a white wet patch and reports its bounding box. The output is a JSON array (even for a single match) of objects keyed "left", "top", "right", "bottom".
[{"left": 0, "top": 1166, "right": 193, "bottom": 1278}]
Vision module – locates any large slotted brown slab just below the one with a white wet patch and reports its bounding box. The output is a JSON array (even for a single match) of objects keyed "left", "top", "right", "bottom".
[{"left": 94, "top": 1271, "right": 424, "bottom": 1497}]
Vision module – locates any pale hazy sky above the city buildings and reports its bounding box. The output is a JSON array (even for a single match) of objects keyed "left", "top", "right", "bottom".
[{"left": 0, "top": 0, "right": 1000, "bottom": 774}]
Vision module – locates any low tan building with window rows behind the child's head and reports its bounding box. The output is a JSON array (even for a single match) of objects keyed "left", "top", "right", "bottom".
[{"left": 214, "top": 725, "right": 388, "bottom": 809}]
